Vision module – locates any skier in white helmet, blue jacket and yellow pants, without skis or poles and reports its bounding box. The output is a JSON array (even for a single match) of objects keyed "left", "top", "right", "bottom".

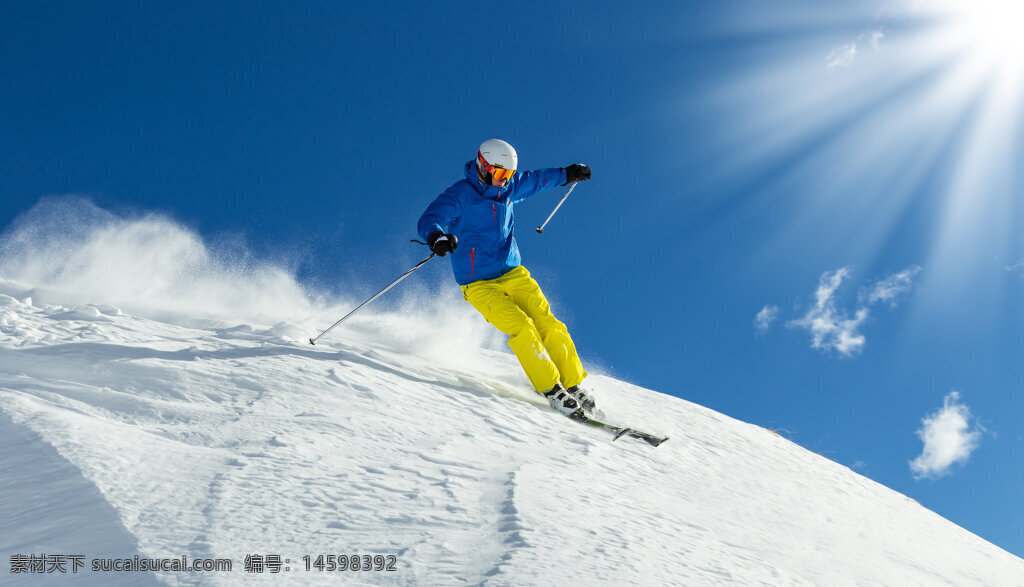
[{"left": 418, "top": 138, "right": 596, "bottom": 420}]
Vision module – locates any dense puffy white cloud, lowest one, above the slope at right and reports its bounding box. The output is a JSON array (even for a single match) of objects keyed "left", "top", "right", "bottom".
[{"left": 910, "top": 391, "right": 983, "bottom": 479}]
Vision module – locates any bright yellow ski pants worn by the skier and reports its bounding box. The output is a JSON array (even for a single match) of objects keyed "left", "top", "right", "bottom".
[{"left": 462, "top": 265, "right": 587, "bottom": 392}]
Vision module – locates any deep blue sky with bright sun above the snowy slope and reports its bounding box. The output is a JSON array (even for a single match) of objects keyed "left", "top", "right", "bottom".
[{"left": 0, "top": 0, "right": 1024, "bottom": 555}]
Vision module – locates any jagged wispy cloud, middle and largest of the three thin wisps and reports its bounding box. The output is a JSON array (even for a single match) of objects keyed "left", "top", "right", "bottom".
[{"left": 788, "top": 267, "right": 869, "bottom": 357}]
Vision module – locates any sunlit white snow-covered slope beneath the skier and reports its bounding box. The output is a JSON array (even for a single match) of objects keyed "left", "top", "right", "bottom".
[{"left": 0, "top": 295, "right": 1024, "bottom": 585}]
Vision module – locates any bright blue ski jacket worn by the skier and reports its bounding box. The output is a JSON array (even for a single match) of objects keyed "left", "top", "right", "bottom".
[{"left": 418, "top": 161, "right": 565, "bottom": 285}]
